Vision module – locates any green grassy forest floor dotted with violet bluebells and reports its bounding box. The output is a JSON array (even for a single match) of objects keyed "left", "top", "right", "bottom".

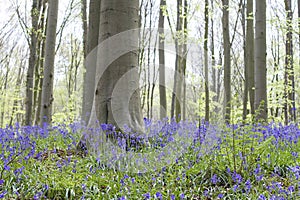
[{"left": 0, "top": 121, "right": 300, "bottom": 199}]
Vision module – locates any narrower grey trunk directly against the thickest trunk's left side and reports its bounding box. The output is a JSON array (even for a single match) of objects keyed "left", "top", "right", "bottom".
[{"left": 81, "top": 0, "right": 101, "bottom": 124}]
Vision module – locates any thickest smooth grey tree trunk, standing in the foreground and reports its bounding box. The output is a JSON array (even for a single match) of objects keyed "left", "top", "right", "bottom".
[{"left": 90, "top": 0, "right": 142, "bottom": 132}]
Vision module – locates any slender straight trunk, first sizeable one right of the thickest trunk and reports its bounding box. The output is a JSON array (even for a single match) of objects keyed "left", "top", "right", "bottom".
[{"left": 158, "top": 0, "right": 167, "bottom": 119}]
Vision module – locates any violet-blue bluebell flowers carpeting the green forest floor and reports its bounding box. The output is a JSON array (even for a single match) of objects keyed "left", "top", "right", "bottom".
[{"left": 0, "top": 119, "right": 300, "bottom": 199}]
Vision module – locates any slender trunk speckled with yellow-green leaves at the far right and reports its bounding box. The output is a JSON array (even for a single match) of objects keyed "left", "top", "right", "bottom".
[{"left": 284, "top": 0, "right": 296, "bottom": 125}]
